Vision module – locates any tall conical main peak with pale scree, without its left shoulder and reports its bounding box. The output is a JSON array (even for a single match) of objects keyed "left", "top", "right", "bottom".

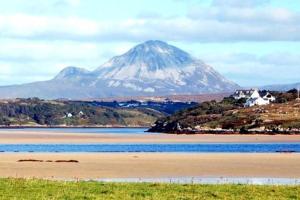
[{"left": 95, "top": 40, "right": 237, "bottom": 94}]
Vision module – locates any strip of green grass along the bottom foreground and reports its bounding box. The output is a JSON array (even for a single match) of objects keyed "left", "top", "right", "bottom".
[{"left": 0, "top": 179, "right": 300, "bottom": 200}]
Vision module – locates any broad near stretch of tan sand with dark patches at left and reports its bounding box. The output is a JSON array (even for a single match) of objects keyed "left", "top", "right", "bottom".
[{"left": 0, "top": 153, "right": 300, "bottom": 179}]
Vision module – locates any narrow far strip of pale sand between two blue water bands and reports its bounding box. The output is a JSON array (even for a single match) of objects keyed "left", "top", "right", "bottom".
[{"left": 0, "top": 130, "right": 300, "bottom": 144}]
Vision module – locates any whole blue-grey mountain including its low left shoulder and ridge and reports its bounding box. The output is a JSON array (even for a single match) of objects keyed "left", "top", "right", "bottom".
[{"left": 0, "top": 40, "right": 239, "bottom": 99}]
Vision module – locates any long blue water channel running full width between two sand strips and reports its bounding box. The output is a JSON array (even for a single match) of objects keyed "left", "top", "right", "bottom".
[{"left": 0, "top": 143, "right": 300, "bottom": 153}]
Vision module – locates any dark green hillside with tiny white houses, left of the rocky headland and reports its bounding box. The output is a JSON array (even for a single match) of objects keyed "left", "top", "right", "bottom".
[{"left": 0, "top": 99, "right": 164, "bottom": 126}]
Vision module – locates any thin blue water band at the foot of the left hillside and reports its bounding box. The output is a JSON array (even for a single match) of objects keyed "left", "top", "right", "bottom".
[{"left": 0, "top": 128, "right": 147, "bottom": 134}]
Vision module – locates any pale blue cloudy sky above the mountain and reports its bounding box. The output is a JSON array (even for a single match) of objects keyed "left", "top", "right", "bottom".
[{"left": 0, "top": 0, "right": 300, "bottom": 86}]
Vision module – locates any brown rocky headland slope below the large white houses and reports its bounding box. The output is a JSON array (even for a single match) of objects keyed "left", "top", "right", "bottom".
[{"left": 149, "top": 91, "right": 300, "bottom": 133}]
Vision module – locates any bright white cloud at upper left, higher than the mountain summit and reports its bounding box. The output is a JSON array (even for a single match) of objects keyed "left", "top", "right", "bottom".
[{"left": 0, "top": 14, "right": 102, "bottom": 40}]
